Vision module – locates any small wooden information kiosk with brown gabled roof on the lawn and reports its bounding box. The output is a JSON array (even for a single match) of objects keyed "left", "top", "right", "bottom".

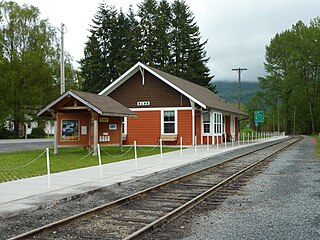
[{"left": 38, "top": 91, "right": 136, "bottom": 153}]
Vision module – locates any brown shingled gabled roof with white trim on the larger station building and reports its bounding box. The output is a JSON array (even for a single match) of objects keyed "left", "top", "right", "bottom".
[{"left": 99, "top": 62, "right": 248, "bottom": 116}]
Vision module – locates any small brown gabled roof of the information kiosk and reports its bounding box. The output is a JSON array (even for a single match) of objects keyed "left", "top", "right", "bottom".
[{"left": 37, "top": 90, "right": 136, "bottom": 117}]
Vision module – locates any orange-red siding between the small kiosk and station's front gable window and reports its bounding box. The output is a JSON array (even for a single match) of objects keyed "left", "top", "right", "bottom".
[{"left": 126, "top": 111, "right": 161, "bottom": 145}]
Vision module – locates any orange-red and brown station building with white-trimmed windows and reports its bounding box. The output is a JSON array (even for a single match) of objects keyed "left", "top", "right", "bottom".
[{"left": 99, "top": 62, "right": 248, "bottom": 145}]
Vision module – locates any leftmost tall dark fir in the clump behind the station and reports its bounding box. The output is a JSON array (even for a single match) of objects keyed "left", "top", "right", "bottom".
[{"left": 80, "top": 4, "right": 118, "bottom": 93}]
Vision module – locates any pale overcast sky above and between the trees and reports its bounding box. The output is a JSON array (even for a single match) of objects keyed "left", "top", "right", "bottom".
[{"left": 15, "top": 0, "right": 320, "bottom": 81}]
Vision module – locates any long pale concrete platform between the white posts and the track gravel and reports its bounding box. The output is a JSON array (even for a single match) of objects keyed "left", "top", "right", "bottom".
[{"left": 0, "top": 136, "right": 286, "bottom": 216}]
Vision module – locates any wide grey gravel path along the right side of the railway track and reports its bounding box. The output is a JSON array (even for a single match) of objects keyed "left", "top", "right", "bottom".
[{"left": 152, "top": 137, "right": 320, "bottom": 240}]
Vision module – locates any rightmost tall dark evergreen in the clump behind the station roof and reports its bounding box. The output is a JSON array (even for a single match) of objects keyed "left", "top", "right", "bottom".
[{"left": 170, "top": 0, "right": 214, "bottom": 89}]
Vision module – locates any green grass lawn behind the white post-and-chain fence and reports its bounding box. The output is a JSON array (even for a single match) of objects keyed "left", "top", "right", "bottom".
[{"left": 0, "top": 147, "right": 179, "bottom": 182}]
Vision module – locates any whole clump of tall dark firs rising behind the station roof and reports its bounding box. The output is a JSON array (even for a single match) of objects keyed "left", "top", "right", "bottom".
[{"left": 81, "top": 0, "right": 215, "bottom": 92}]
